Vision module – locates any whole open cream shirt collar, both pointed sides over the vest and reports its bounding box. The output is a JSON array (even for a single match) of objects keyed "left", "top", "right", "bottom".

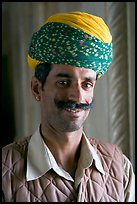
[{"left": 26, "top": 128, "right": 105, "bottom": 183}]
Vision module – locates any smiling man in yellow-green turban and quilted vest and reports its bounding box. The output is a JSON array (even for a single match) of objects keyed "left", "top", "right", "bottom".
[{"left": 2, "top": 12, "right": 135, "bottom": 202}]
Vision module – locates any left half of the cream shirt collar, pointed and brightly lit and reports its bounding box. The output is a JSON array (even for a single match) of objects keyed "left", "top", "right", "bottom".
[{"left": 26, "top": 128, "right": 73, "bottom": 181}]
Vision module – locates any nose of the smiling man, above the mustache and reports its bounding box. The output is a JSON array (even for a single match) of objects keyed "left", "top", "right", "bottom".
[{"left": 68, "top": 84, "right": 85, "bottom": 103}]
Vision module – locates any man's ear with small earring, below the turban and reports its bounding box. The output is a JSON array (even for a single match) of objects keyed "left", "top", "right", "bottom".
[{"left": 31, "top": 76, "right": 41, "bottom": 101}]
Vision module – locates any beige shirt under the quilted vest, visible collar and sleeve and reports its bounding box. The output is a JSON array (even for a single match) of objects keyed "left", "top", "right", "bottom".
[{"left": 26, "top": 128, "right": 135, "bottom": 202}]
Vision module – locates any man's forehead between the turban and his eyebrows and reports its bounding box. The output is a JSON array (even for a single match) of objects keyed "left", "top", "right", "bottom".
[{"left": 50, "top": 64, "right": 96, "bottom": 80}]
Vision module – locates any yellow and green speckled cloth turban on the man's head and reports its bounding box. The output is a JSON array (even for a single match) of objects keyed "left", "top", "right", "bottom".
[{"left": 27, "top": 11, "right": 112, "bottom": 77}]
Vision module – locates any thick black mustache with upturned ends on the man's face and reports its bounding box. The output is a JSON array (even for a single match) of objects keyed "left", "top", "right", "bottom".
[{"left": 54, "top": 99, "right": 94, "bottom": 110}]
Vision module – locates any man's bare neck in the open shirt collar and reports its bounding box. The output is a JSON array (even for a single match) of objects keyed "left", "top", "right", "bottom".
[{"left": 41, "top": 123, "right": 83, "bottom": 176}]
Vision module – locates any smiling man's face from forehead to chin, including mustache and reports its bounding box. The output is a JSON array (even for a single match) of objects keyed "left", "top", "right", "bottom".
[{"left": 41, "top": 64, "right": 96, "bottom": 132}]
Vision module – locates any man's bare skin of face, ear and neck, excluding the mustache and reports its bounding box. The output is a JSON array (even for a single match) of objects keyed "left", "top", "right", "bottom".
[{"left": 31, "top": 64, "right": 96, "bottom": 175}]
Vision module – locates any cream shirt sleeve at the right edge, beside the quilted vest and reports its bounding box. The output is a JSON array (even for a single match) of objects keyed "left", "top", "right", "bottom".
[{"left": 123, "top": 155, "right": 135, "bottom": 202}]
